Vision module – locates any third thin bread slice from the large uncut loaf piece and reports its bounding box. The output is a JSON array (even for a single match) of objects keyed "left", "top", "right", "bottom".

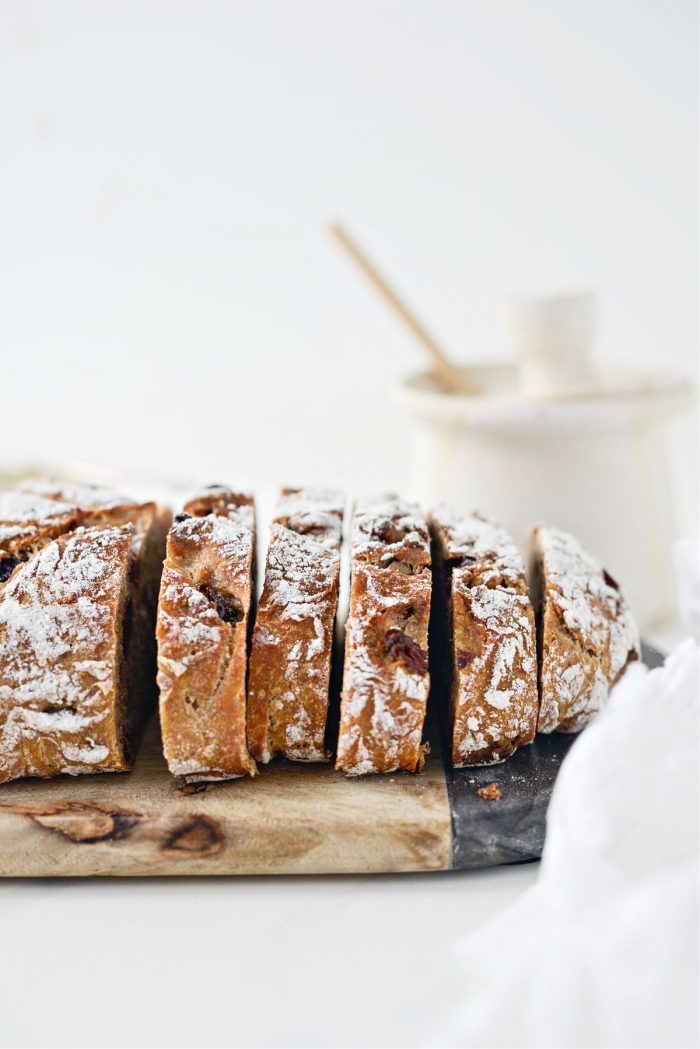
[{"left": 336, "top": 496, "right": 431, "bottom": 775}]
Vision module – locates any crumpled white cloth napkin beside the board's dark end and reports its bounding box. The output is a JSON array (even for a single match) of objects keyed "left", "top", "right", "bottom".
[{"left": 437, "top": 641, "right": 700, "bottom": 1049}]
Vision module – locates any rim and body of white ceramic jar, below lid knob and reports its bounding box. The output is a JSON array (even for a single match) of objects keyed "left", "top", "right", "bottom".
[{"left": 398, "top": 365, "right": 691, "bottom": 625}]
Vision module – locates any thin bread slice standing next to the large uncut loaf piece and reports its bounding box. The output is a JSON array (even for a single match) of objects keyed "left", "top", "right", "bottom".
[{"left": 156, "top": 486, "right": 256, "bottom": 783}]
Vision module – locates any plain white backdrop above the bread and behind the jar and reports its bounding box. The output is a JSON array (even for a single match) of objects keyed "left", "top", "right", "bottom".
[{"left": 0, "top": 0, "right": 698, "bottom": 497}]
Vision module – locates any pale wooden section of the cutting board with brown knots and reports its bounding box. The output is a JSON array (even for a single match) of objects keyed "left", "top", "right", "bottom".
[{"left": 0, "top": 723, "right": 451, "bottom": 877}]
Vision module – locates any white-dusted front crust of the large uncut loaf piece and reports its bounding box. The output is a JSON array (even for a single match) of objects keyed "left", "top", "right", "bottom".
[{"left": 0, "top": 525, "right": 133, "bottom": 775}]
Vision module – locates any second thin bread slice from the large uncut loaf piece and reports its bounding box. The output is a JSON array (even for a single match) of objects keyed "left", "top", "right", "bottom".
[{"left": 248, "top": 488, "right": 344, "bottom": 762}]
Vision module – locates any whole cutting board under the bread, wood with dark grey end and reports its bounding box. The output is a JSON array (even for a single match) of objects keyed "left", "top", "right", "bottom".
[{"left": 0, "top": 648, "right": 661, "bottom": 878}]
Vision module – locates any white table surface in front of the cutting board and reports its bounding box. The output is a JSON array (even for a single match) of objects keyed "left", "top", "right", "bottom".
[{"left": 0, "top": 863, "right": 537, "bottom": 1049}]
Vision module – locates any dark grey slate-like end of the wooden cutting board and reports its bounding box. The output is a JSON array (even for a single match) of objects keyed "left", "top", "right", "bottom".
[{"left": 445, "top": 644, "right": 664, "bottom": 871}]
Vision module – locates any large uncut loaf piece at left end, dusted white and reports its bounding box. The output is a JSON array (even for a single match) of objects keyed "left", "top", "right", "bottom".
[{"left": 0, "top": 483, "right": 169, "bottom": 782}]
